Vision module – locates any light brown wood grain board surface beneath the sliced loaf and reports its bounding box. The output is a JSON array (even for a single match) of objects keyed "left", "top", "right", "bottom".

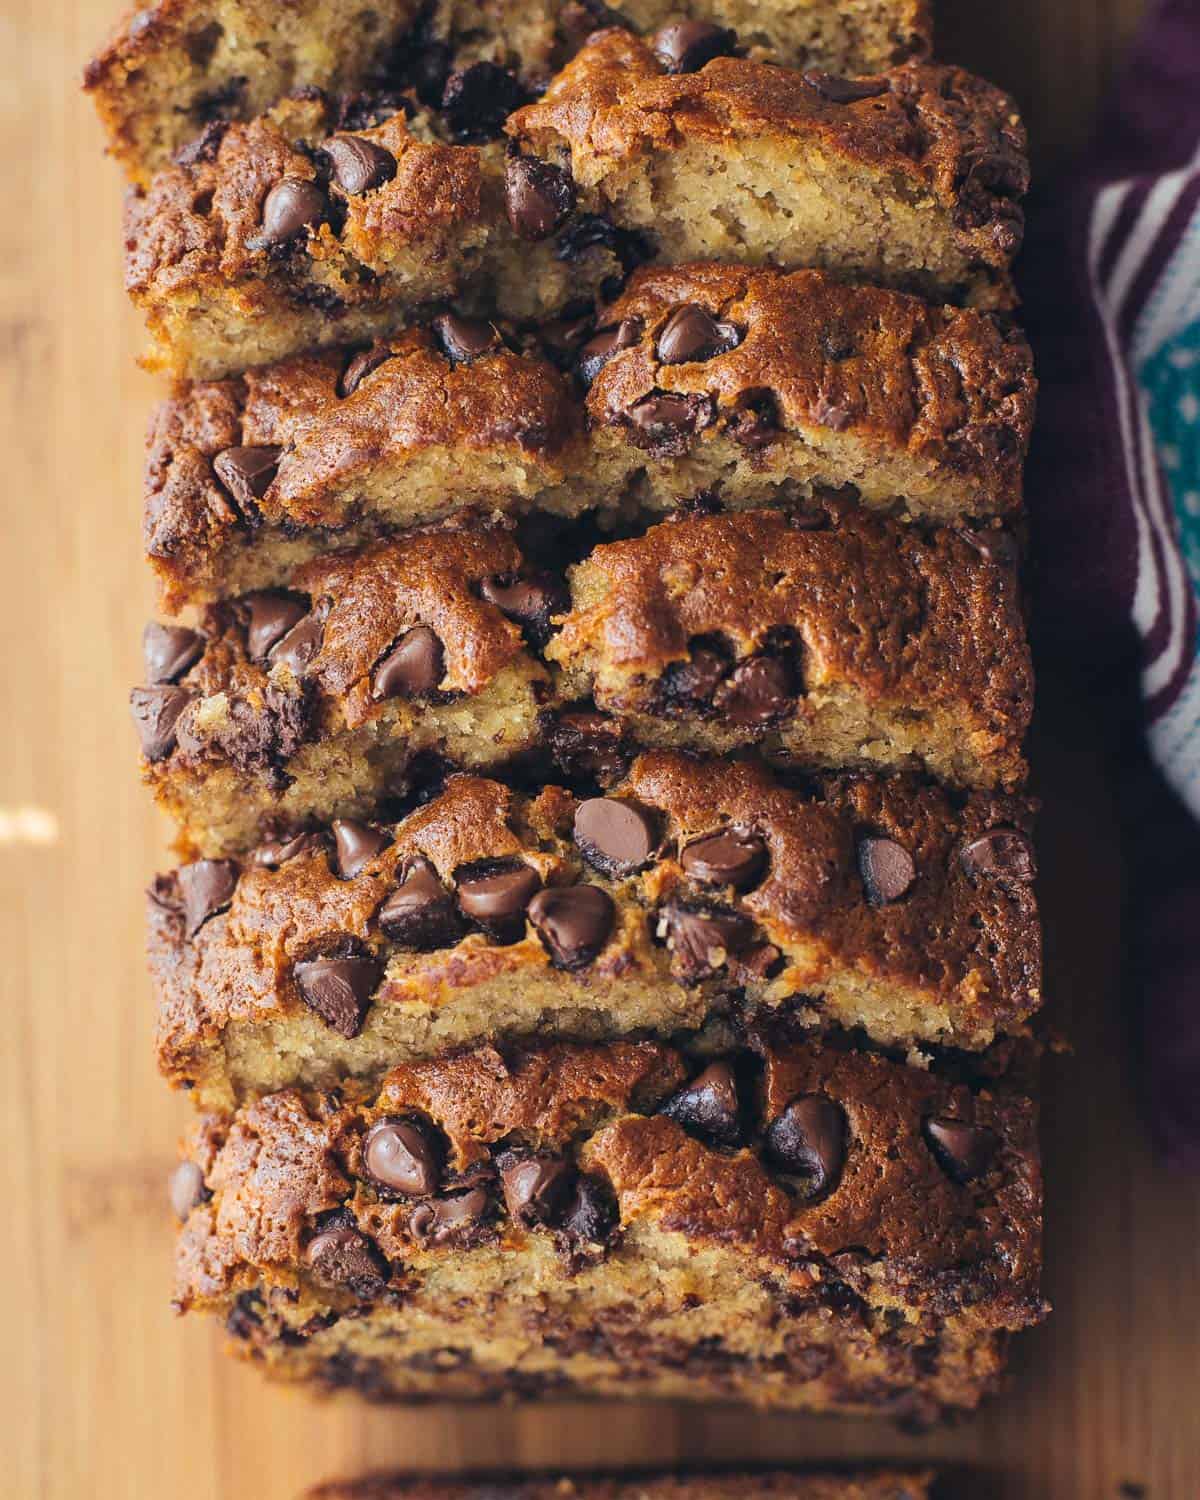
[{"left": 0, "top": 0, "right": 1200, "bottom": 1500}]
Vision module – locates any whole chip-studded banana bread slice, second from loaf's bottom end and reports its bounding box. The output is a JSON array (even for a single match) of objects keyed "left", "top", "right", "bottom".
[{"left": 147, "top": 752, "right": 1041, "bottom": 1107}]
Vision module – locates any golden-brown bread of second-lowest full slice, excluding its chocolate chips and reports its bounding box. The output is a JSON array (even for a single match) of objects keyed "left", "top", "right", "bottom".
[{"left": 149, "top": 753, "right": 1041, "bottom": 1101}]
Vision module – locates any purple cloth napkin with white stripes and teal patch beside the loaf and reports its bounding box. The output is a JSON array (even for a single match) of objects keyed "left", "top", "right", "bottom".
[{"left": 1025, "top": 0, "right": 1200, "bottom": 1167}]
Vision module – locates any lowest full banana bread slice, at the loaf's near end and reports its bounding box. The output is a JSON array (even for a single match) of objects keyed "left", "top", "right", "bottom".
[{"left": 173, "top": 1043, "right": 1044, "bottom": 1422}]
